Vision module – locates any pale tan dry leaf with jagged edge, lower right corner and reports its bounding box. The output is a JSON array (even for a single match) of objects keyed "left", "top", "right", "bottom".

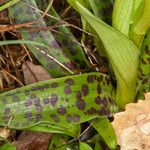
[{"left": 112, "top": 92, "right": 150, "bottom": 150}]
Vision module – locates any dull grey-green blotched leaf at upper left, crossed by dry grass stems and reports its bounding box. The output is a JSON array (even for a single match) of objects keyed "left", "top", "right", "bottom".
[{"left": 9, "top": 0, "right": 88, "bottom": 77}]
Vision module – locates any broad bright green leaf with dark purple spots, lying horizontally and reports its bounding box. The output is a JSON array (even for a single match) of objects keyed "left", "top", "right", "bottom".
[{"left": 0, "top": 73, "right": 116, "bottom": 131}]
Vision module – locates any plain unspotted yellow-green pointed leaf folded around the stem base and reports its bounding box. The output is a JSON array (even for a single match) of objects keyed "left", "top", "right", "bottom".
[{"left": 76, "top": 2, "right": 139, "bottom": 108}]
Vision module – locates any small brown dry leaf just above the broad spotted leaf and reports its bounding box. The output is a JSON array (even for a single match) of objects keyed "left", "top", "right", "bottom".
[{"left": 22, "top": 61, "right": 52, "bottom": 84}]
